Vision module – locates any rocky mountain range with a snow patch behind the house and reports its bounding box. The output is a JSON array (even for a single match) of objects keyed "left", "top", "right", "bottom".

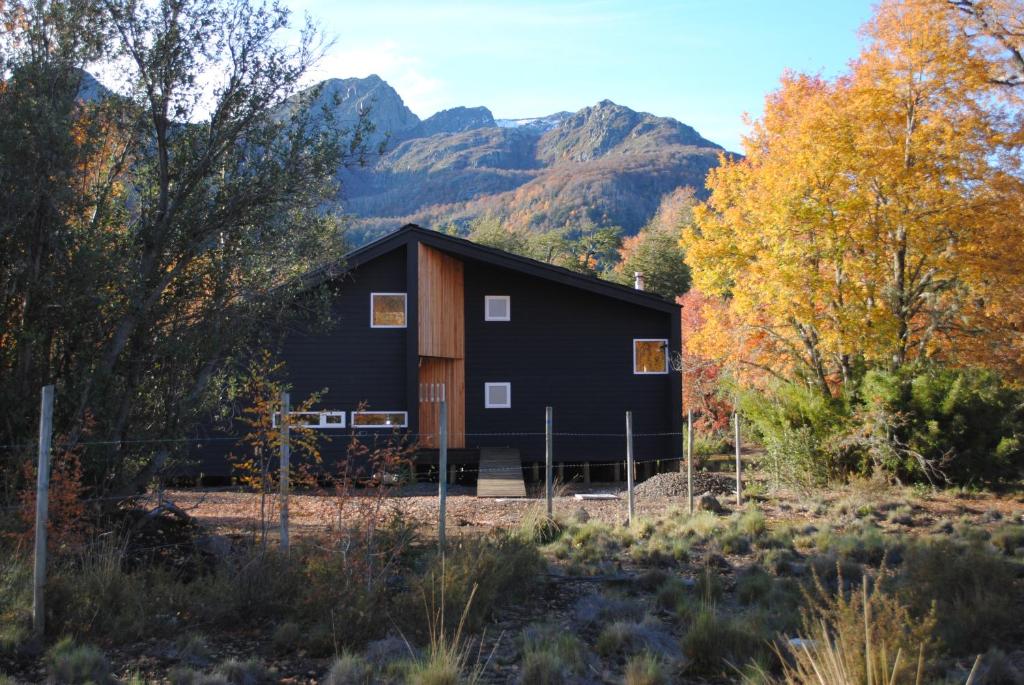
[{"left": 291, "top": 76, "right": 725, "bottom": 243}]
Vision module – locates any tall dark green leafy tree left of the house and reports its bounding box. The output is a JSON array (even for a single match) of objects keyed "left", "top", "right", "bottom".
[{"left": 0, "top": 0, "right": 369, "bottom": 491}]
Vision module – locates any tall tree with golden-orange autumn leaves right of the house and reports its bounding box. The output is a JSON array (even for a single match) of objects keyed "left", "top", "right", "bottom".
[{"left": 682, "top": 0, "right": 1024, "bottom": 395}]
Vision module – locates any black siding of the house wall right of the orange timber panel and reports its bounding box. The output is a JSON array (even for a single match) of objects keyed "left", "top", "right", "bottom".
[{"left": 465, "top": 260, "right": 680, "bottom": 462}]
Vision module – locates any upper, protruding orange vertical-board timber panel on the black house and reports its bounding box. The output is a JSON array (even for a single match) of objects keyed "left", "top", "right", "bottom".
[{"left": 419, "top": 244, "right": 466, "bottom": 359}]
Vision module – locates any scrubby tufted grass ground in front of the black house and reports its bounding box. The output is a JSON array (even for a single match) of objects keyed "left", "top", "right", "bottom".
[{"left": 0, "top": 466, "right": 1024, "bottom": 685}]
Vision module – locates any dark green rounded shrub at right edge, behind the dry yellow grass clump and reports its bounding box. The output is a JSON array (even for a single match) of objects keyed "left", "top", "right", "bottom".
[{"left": 895, "top": 539, "right": 1020, "bottom": 654}]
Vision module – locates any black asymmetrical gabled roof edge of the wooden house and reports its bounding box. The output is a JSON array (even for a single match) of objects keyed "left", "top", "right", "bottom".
[{"left": 310, "top": 223, "right": 679, "bottom": 312}]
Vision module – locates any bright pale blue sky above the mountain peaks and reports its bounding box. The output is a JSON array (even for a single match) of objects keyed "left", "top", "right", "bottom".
[{"left": 289, "top": 0, "right": 872, "bottom": 149}]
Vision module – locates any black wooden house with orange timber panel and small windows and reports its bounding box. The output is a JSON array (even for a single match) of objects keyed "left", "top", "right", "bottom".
[{"left": 198, "top": 224, "right": 681, "bottom": 491}]
